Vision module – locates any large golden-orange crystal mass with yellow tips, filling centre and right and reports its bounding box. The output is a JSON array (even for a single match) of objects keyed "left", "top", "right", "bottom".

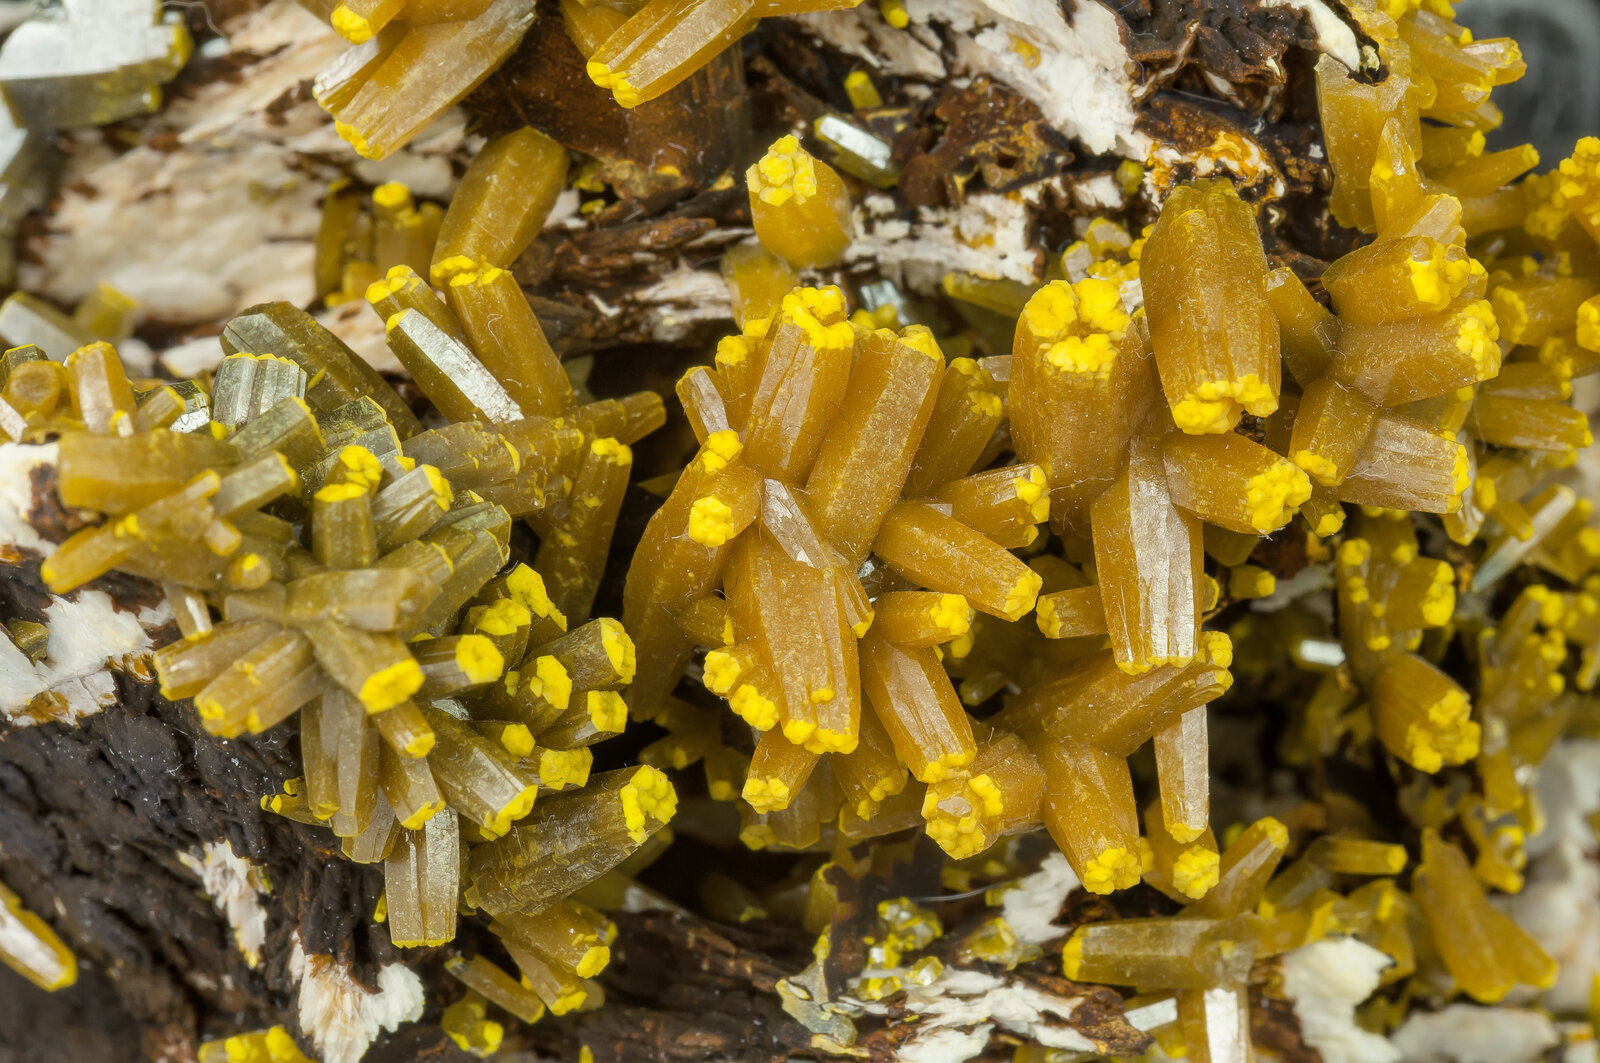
[{"left": 624, "top": 3, "right": 1600, "bottom": 1060}]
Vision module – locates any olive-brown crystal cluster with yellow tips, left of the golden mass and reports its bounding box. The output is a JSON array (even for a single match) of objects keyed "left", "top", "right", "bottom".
[{"left": 3, "top": 120, "right": 677, "bottom": 1030}]
